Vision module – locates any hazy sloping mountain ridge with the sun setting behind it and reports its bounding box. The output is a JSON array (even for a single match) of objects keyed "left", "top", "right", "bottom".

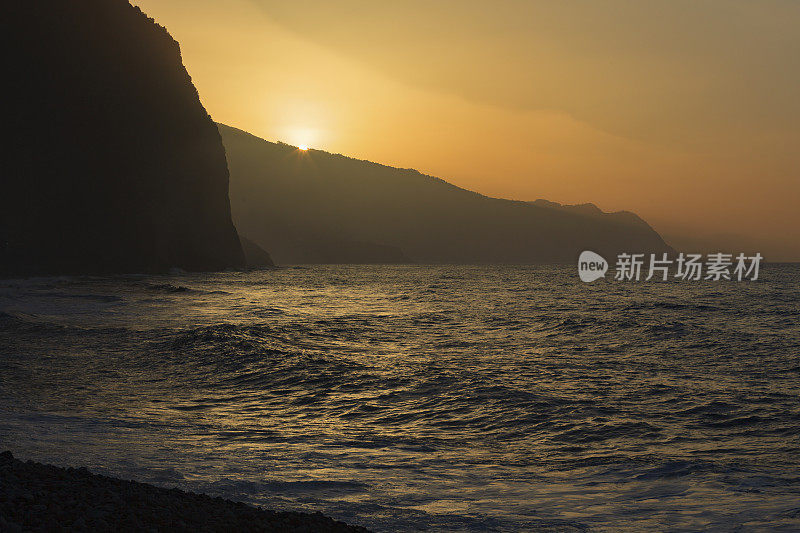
[{"left": 219, "top": 125, "right": 671, "bottom": 263}]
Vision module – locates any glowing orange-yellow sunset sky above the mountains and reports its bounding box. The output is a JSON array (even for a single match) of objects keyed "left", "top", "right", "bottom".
[{"left": 134, "top": 0, "right": 800, "bottom": 260}]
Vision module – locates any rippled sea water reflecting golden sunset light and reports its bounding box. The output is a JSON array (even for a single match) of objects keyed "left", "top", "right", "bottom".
[{"left": 0, "top": 265, "right": 800, "bottom": 531}]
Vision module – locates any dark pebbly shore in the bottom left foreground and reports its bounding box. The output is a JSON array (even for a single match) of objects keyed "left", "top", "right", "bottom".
[{"left": 0, "top": 452, "right": 367, "bottom": 533}]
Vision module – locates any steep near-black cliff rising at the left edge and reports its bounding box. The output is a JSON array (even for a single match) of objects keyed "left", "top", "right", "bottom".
[{"left": 0, "top": 0, "right": 244, "bottom": 275}]
